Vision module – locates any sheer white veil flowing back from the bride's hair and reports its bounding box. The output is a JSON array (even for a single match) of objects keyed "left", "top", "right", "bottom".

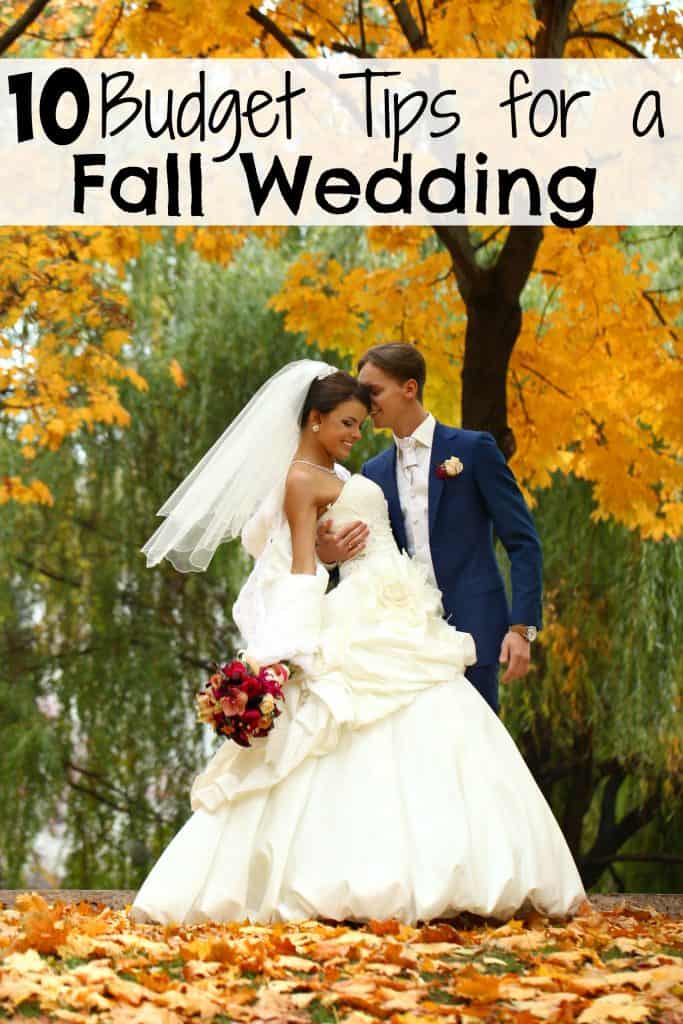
[{"left": 140, "top": 359, "right": 337, "bottom": 572}]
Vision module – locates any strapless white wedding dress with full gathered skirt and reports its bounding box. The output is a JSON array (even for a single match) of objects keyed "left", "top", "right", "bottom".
[{"left": 131, "top": 475, "right": 585, "bottom": 924}]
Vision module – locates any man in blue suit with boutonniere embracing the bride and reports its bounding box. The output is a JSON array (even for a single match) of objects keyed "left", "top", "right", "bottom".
[{"left": 318, "top": 343, "right": 543, "bottom": 712}]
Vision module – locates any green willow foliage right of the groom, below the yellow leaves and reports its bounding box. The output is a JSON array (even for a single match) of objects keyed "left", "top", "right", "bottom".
[{"left": 503, "top": 477, "right": 683, "bottom": 891}]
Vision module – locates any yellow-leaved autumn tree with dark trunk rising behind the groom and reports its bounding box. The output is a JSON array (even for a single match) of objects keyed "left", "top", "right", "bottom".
[{"left": 0, "top": 0, "right": 683, "bottom": 538}]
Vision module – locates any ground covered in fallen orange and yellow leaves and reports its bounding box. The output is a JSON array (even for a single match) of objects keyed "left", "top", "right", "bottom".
[{"left": 0, "top": 893, "right": 683, "bottom": 1024}]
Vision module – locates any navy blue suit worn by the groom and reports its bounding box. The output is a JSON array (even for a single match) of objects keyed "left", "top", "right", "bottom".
[{"left": 362, "top": 423, "right": 543, "bottom": 712}]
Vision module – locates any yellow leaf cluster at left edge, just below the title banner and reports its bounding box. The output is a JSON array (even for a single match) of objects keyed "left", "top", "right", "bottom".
[{"left": 0, "top": 227, "right": 148, "bottom": 475}]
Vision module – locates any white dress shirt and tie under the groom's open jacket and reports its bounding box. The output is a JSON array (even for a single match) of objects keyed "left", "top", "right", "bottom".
[{"left": 393, "top": 413, "right": 438, "bottom": 587}]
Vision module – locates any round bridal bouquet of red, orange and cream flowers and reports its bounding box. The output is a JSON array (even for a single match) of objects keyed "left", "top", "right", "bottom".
[{"left": 197, "top": 657, "right": 290, "bottom": 746}]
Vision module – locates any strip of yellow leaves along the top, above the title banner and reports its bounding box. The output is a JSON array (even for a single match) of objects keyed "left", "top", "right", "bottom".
[{"left": 0, "top": 0, "right": 683, "bottom": 57}]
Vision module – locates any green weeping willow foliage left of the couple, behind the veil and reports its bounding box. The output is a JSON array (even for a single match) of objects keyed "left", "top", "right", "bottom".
[{"left": 0, "top": 232, "right": 373, "bottom": 888}]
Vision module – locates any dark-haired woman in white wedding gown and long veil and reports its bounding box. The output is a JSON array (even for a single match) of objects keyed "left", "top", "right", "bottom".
[{"left": 131, "top": 359, "right": 585, "bottom": 924}]
